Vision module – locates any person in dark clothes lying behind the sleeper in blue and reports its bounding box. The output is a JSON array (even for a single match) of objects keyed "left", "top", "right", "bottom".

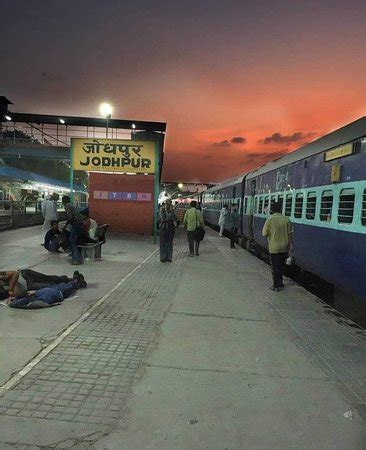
[{"left": 0, "top": 269, "right": 85, "bottom": 298}]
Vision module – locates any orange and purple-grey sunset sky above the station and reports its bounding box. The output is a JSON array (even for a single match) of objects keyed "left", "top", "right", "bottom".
[{"left": 0, "top": 0, "right": 366, "bottom": 182}]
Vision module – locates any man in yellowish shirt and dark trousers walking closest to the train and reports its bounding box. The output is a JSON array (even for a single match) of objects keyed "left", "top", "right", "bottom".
[{"left": 262, "top": 202, "right": 293, "bottom": 291}]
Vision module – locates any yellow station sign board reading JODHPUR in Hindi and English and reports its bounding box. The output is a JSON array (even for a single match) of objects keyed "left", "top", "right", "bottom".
[{"left": 71, "top": 138, "right": 155, "bottom": 173}]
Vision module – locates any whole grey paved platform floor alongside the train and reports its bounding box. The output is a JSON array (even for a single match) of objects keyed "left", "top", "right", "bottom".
[{"left": 0, "top": 228, "right": 366, "bottom": 450}]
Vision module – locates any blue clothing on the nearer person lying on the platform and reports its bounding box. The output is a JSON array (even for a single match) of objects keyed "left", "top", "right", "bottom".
[{"left": 9, "top": 281, "right": 77, "bottom": 308}]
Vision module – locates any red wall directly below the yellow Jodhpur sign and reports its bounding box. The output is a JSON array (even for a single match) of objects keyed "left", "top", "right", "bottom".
[{"left": 89, "top": 172, "right": 154, "bottom": 235}]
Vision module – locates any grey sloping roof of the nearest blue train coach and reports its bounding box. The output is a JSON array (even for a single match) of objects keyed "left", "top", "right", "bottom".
[{"left": 246, "top": 117, "right": 366, "bottom": 179}]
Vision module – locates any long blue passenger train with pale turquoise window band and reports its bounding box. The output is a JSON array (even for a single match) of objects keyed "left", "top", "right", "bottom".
[{"left": 197, "top": 117, "right": 366, "bottom": 326}]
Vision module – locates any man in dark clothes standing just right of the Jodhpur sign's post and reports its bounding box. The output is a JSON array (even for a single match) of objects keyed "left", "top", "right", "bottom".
[{"left": 159, "top": 198, "right": 177, "bottom": 262}]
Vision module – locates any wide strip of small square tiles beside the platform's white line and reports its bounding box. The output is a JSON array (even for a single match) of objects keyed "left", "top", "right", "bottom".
[{"left": 0, "top": 237, "right": 186, "bottom": 442}]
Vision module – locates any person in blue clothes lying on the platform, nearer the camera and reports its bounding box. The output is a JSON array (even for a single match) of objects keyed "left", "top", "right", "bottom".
[{"left": 7, "top": 273, "right": 86, "bottom": 309}]
